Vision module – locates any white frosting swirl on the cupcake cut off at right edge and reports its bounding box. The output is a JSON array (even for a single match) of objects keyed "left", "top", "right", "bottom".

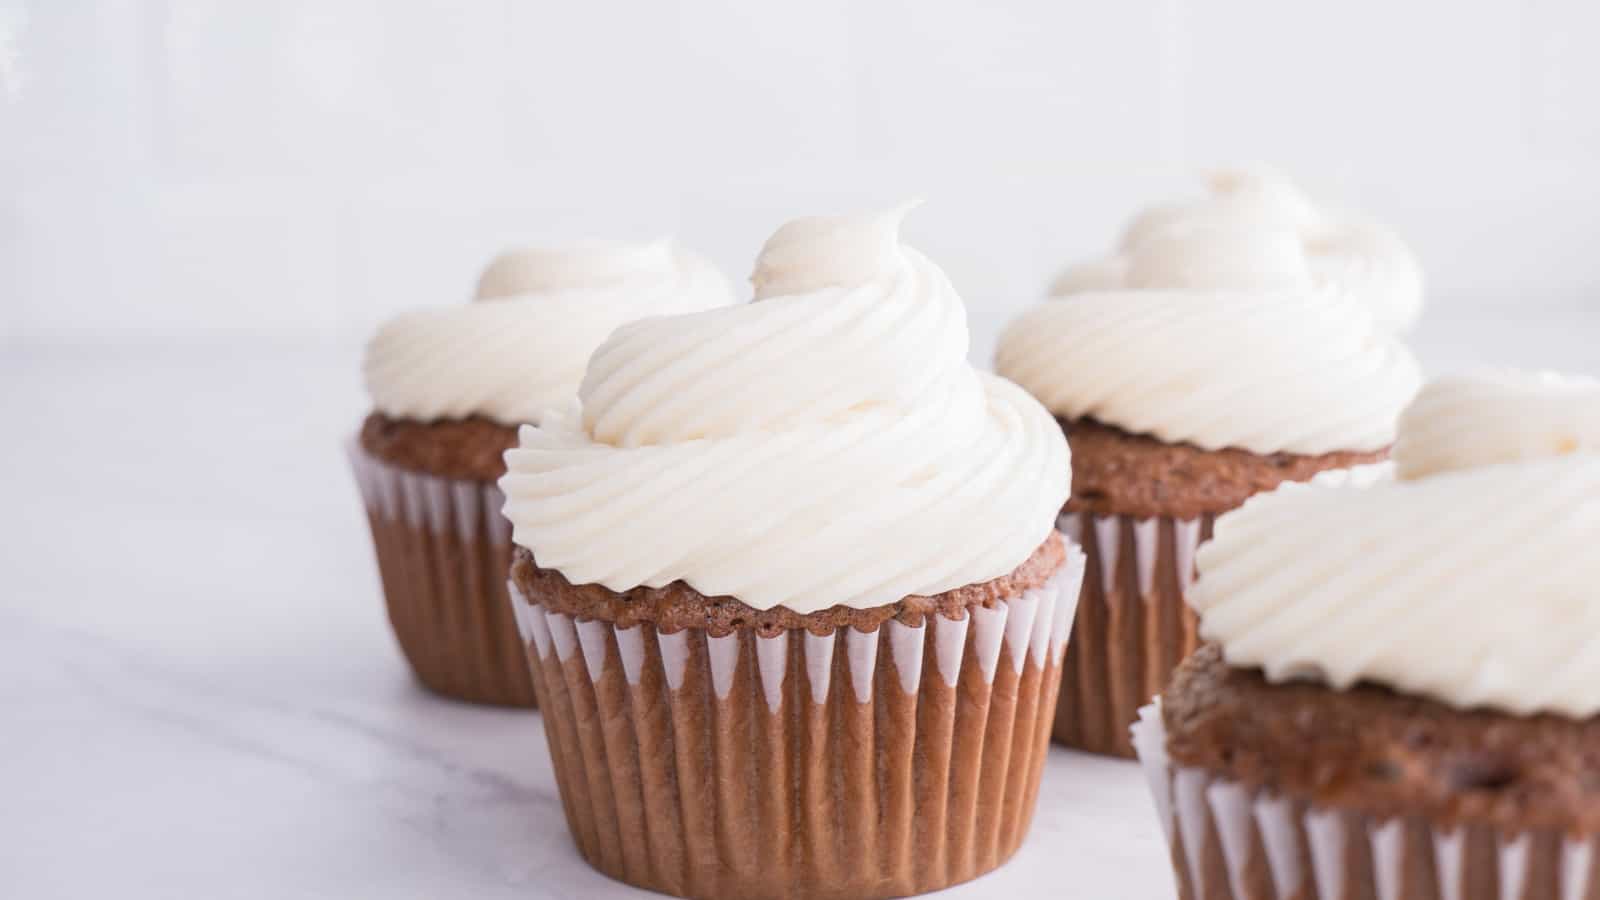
[{"left": 1189, "top": 373, "right": 1600, "bottom": 717}]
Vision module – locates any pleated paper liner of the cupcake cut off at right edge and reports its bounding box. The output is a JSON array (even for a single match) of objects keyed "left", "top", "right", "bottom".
[{"left": 1133, "top": 703, "right": 1600, "bottom": 900}]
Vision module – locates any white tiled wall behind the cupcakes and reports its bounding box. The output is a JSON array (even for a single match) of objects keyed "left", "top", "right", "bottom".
[{"left": 0, "top": 0, "right": 1600, "bottom": 360}]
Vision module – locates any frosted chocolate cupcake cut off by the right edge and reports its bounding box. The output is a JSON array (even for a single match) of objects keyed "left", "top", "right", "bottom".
[{"left": 1134, "top": 373, "right": 1600, "bottom": 900}]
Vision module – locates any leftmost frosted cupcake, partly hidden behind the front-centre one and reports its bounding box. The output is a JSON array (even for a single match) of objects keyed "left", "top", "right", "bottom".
[{"left": 350, "top": 242, "right": 733, "bottom": 706}]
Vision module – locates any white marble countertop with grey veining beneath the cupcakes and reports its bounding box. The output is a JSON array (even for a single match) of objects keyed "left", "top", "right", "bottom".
[{"left": 0, "top": 315, "right": 1600, "bottom": 900}]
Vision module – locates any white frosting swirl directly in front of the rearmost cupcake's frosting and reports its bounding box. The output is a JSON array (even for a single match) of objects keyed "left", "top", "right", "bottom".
[{"left": 995, "top": 224, "right": 1421, "bottom": 455}]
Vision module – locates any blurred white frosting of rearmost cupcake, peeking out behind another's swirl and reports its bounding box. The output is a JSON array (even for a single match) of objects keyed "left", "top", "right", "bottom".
[{"left": 1050, "top": 171, "right": 1422, "bottom": 333}]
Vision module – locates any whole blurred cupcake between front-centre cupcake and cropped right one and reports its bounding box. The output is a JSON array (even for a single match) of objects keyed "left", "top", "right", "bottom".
[{"left": 997, "top": 171, "right": 1421, "bottom": 756}]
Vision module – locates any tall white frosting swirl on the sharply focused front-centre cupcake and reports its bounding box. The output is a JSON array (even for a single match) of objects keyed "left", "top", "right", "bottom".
[{"left": 501, "top": 210, "right": 1070, "bottom": 613}]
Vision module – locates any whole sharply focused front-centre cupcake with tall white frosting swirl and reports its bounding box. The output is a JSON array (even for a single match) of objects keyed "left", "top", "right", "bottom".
[{"left": 501, "top": 210, "right": 1083, "bottom": 898}]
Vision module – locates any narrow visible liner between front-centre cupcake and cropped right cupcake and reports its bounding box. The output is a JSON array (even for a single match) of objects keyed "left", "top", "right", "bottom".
[{"left": 1054, "top": 512, "right": 1214, "bottom": 759}]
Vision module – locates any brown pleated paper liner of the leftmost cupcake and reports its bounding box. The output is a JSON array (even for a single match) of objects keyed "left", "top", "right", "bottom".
[{"left": 349, "top": 444, "right": 534, "bottom": 706}]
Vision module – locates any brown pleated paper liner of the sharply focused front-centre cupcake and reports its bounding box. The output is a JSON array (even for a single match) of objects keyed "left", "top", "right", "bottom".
[{"left": 512, "top": 549, "right": 1083, "bottom": 898}]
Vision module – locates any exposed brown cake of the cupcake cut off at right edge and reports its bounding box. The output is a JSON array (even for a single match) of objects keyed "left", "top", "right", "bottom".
[{"left": 1162, "top": 647, "right": 1600, "bottom": 833}]
